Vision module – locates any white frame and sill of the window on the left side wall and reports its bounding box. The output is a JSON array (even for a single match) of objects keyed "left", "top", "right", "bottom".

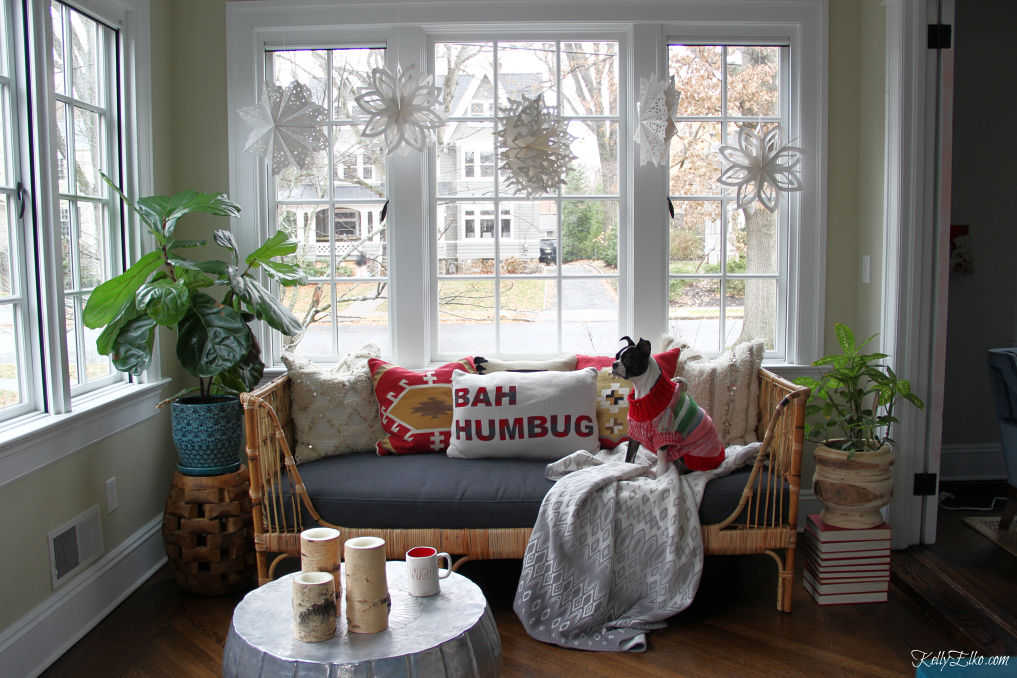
[{"left": 0, "top": 0, "right": 161, "bottom": 487}]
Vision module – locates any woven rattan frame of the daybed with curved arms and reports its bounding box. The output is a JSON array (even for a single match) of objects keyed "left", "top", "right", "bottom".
[{"left": 240, "top": 369, "right": 809, "bottom": 612}]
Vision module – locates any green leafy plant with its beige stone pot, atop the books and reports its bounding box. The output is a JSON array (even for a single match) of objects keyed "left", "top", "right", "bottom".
[{"left": 795, "top": 323, "right": 924, "bottom": 528}]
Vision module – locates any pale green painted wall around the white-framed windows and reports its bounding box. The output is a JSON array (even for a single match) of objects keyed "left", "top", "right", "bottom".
[{"left": 0, "top": 0, "right": 885, "bottom": 628}]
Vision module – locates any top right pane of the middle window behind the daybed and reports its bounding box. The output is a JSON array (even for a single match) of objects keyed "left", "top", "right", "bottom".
[{"left": 560, "top": 42, "right": 618, "bottom": 116}]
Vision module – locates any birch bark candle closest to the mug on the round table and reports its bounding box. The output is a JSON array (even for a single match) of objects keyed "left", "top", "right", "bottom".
[{"left": 344, "top": 537, "right": 392, "bottom": 633}]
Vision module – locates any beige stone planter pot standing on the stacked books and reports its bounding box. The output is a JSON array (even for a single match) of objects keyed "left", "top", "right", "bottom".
[{"left": 813, "top": 444, "right": 894, "bottom": 529}]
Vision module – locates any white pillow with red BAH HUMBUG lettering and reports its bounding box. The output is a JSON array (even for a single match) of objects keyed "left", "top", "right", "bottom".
[{"left": 448, "top": 367, "right": 600, "bottom": 459}]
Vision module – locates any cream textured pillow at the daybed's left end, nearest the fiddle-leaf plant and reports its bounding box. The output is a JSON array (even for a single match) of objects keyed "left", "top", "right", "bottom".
[{"left": 283, "top": 344, "right": 384, "bottom": 464}]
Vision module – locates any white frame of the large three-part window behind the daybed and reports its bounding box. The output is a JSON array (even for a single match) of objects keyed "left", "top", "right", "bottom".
[{"left": 226, "top": 0, "right": 828, "bottom": 367}]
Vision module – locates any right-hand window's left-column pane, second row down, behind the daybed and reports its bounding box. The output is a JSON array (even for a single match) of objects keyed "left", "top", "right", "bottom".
[{"left": 669, "top": 122, "right": 721, "bottom": 195}]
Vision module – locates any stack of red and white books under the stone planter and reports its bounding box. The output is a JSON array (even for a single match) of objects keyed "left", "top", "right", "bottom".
[{"left": 802, "top": 514, "right": 890, "bottom": 605}]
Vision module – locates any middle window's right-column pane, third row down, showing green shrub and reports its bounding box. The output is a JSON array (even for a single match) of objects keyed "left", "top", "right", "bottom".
[{"left": 561, "top": 200, "right": 618, "bottom": 275}]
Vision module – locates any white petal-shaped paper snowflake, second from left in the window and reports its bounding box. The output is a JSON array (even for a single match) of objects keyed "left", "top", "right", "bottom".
[{"left": 354, "top": 64, "right": 444, "bottom": 153}]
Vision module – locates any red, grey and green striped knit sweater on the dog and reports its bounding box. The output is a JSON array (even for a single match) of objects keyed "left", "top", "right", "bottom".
[{"left": 629, "top": 376, "right": 724, "bottom": 471}]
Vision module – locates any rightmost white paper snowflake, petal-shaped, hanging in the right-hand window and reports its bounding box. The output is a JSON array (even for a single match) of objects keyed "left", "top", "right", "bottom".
[{"left": 717, "top": 125, "right": 804, "bottom": 211}]
